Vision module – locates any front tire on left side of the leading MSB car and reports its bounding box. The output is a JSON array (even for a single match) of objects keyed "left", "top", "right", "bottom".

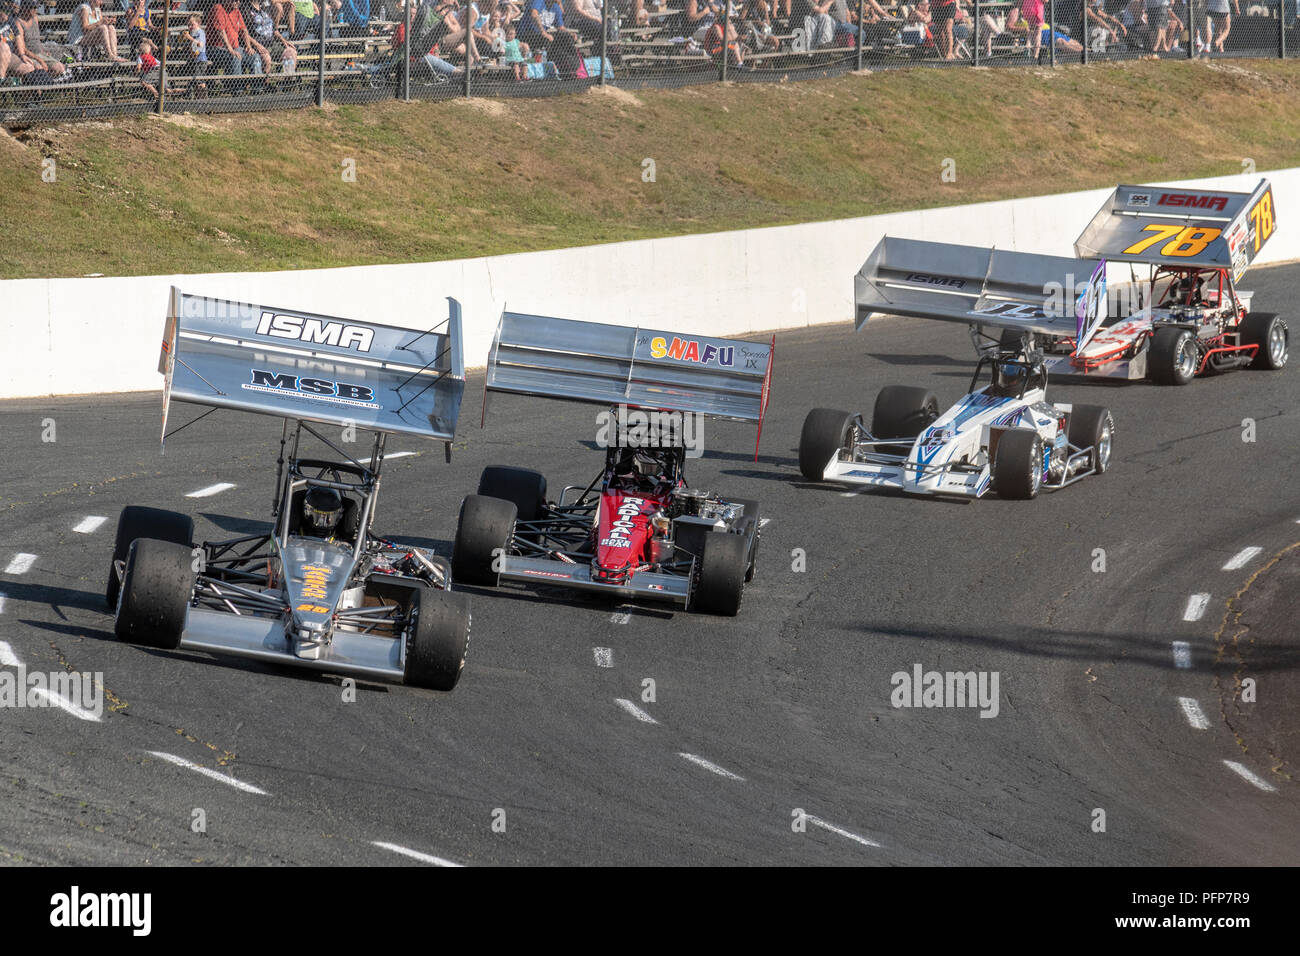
[{"left": 113, "top": 537, "right": 195, "bottom": 650}]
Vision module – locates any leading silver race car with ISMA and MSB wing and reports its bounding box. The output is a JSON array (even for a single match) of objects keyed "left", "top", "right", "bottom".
[{"left": 107, "top": 289, "right": 471, "bottom": 691}]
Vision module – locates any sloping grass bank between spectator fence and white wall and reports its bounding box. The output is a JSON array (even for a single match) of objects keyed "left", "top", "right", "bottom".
[{"left": 0, "top": 61, "right": 1300, "bottom": 278}]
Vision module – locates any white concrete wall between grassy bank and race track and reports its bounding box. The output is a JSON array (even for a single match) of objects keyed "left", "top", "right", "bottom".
[{"left": 0, "top": 169, "right": 1300, "bottom": 398}]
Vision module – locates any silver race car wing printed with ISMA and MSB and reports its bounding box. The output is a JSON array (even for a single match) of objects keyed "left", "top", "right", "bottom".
[{"left": 159, "top": 286, "right": 465, "bottom": 445}]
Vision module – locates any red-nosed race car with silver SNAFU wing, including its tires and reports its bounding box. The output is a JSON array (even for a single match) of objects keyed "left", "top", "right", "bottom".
[{"left": 451, "top": 312, "right": 775, "bottom": 615}]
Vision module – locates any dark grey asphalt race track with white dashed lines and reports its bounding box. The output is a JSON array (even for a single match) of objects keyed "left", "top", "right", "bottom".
[{"left": 0, "top": 265, "right": 1300, "bottom": 866}]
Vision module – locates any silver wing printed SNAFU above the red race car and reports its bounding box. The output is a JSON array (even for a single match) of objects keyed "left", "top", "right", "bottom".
[{"left": 484, "top": 312, "right": 776, "bottom": 457}]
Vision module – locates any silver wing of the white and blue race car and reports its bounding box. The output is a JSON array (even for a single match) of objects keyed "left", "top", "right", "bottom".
[{"left": 853, "top": 235, "right": 1106, "bottom": 343}]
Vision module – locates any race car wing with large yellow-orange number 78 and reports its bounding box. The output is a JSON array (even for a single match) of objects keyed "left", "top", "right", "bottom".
[{"left": 1074, "top": 179, "right": 1278, "bottom": 281}]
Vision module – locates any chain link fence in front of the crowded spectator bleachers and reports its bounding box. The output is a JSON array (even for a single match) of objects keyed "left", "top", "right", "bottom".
[{"left": 0, "top": 0, "right": 1300, "bottom": 126}]
